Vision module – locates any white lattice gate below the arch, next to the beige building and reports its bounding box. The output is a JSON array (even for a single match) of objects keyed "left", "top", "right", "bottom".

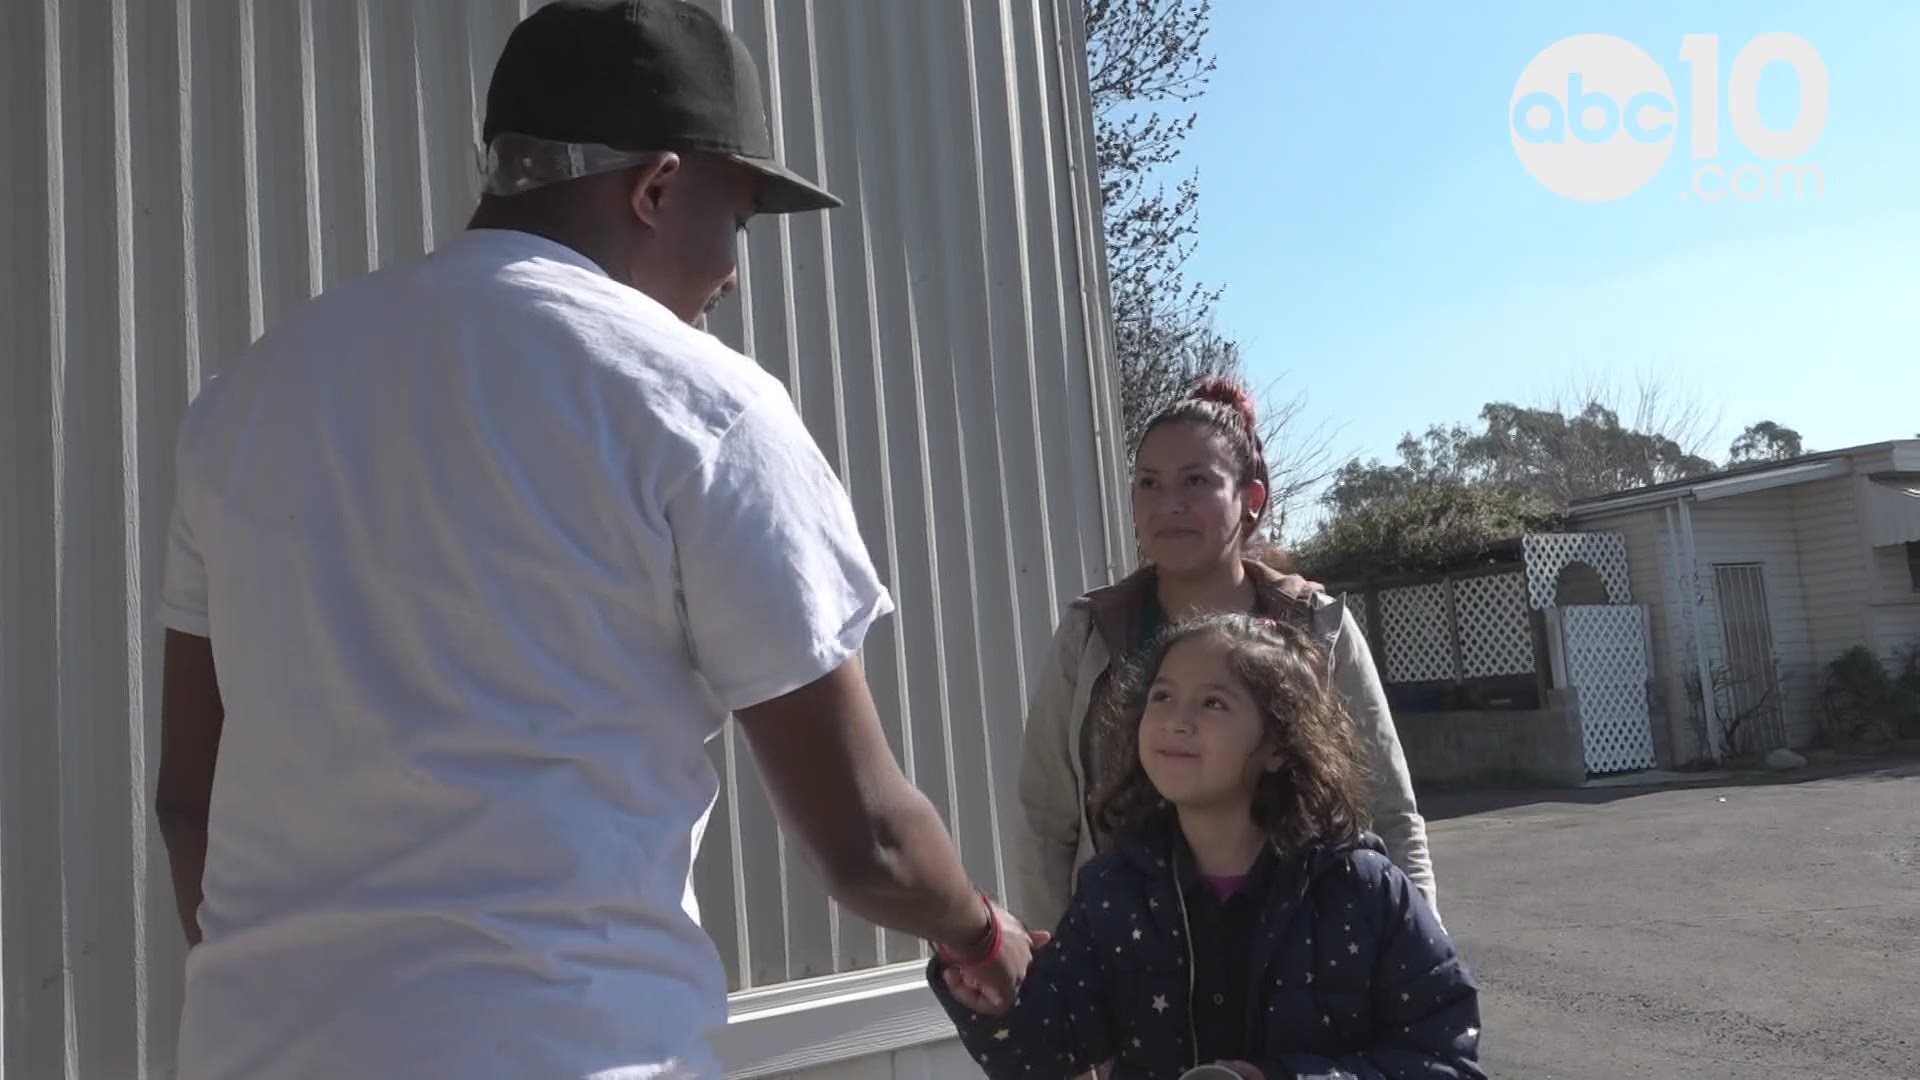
[{"left": 1559, "top": 605, "right": 1653, "bottom": 773}]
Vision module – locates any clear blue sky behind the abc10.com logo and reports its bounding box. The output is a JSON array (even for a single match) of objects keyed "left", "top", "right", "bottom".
[{"left": 1183, "top": 0, "right": 1920, "bottom": 522}]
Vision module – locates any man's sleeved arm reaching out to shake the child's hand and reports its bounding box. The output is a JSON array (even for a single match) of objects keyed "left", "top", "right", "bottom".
[{"left": 666, "top": 392, "right": 1029, "bottom": 1001}]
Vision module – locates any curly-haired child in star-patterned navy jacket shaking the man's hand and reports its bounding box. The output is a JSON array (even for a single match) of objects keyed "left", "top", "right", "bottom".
[{"left": 929, "top": 615, "right": 1484, "bottom": 1080}]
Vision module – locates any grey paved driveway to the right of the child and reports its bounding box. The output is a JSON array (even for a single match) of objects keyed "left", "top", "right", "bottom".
[{"left": 1423, "top": 761, "right": 1920, "bottom": 1080}]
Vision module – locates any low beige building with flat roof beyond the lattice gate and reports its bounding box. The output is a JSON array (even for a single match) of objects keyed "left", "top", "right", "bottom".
[{"left": 1571, "top": 440, "right": 1920, "bottom": 765}]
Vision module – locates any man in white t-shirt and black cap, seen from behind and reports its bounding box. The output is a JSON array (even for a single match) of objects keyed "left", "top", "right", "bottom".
[{"left": 157, "top": 0, "right": 1031, "bottom": 1080}]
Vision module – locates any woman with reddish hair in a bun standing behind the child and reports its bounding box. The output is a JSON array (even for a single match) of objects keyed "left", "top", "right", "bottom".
[{"left": 1020, "top": 379, "right": 1436, "bottom": 926}]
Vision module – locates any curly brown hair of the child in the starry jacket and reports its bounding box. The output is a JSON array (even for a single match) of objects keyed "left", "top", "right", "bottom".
[{"left": 1094, "top": 615, "right": 1367, "bottom": 853}]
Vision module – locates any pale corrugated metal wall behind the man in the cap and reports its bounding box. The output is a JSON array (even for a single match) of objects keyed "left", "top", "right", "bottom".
[{"left": 0, "top": 0, "right": 1125, "bottom": 1080}]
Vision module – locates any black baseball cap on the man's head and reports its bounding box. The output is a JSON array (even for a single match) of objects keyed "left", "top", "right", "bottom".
[{"left": 482, "top": 0, "right": 841, "bottom": 213}]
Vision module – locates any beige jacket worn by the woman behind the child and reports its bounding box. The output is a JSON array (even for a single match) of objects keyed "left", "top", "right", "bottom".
[{"left": 1016, "top": 563, "right": 1436, "bottom": 926}]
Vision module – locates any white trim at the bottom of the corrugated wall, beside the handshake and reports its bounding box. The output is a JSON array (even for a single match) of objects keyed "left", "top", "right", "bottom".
[{"left": 714, "top": 961, "right": 954, "bottom": 1080}]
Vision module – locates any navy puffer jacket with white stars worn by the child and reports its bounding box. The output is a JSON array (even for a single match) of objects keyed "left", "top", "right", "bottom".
[{"left": 927, "top": 821, "right": 1486, "bottom": 1080}]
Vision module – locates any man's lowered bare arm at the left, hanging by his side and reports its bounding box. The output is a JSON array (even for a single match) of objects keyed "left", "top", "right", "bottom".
[{"left": 154, "top": 630, "right": 227, "bottom": 945}]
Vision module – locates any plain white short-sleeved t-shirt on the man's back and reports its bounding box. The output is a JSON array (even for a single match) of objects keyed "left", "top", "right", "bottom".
[{"left": 161, "top": 231, "right": 891, "bottom": 1080}]
